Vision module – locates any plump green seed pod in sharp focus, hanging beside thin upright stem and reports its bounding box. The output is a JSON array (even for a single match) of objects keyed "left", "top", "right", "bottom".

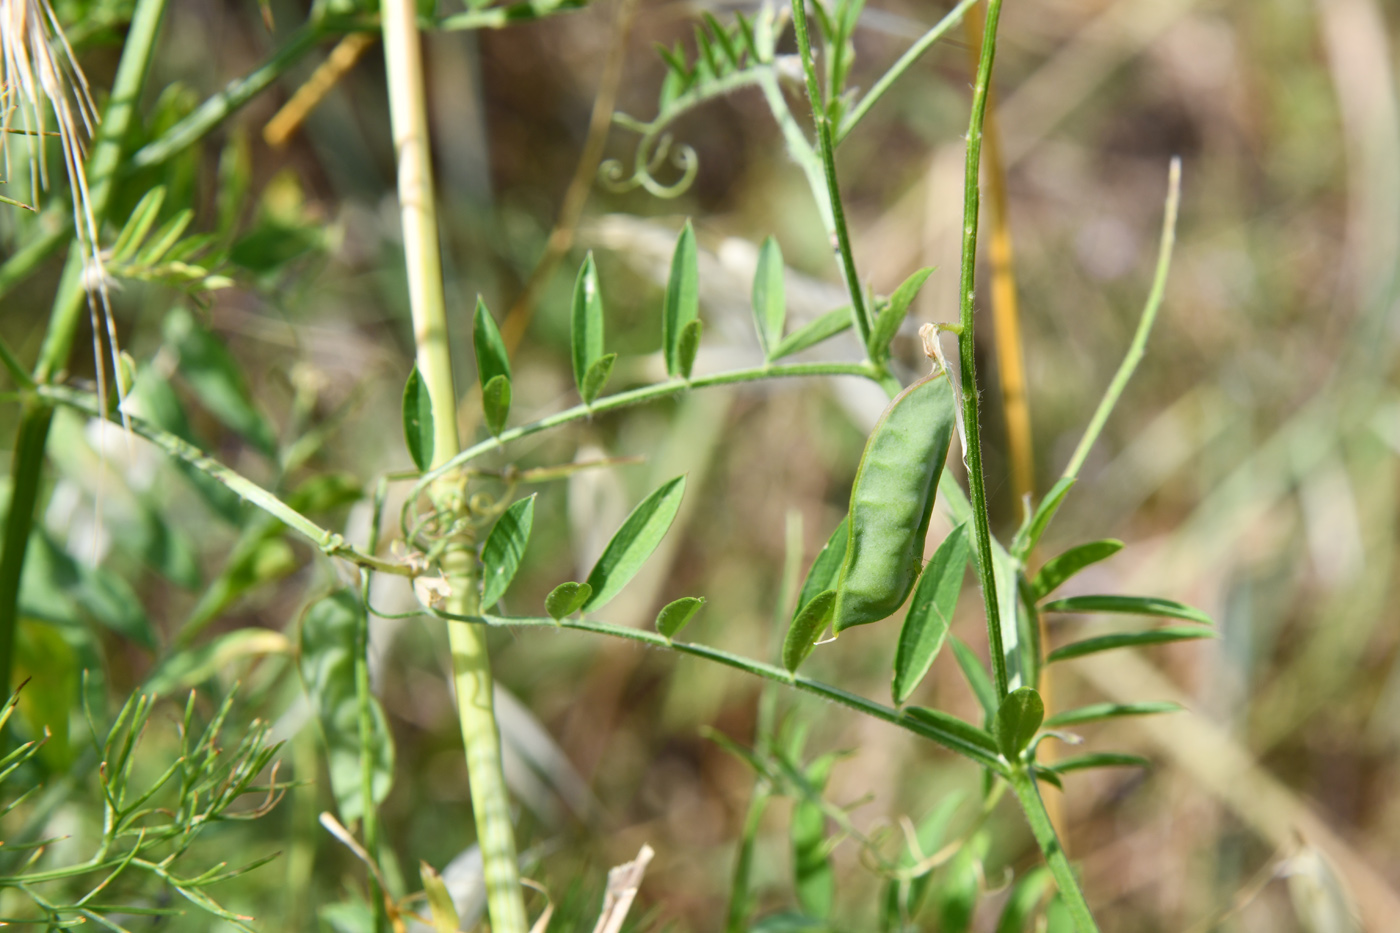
[{"left": 833, "top": 371, "right": 956, "bottom": 632}]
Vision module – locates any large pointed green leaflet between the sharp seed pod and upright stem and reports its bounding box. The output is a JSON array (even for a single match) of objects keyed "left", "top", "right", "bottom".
[{"left": 890, "top": 524, "right": 972, "bottom": 706}]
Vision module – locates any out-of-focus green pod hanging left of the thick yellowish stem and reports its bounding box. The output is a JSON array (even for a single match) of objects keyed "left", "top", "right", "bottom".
[{"left": 300, "top": 590, "right": 393, "bottom": 822}]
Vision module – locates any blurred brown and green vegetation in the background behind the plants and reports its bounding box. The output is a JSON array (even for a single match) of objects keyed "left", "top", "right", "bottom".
[{"left": 0, "top": 0, "right": 1400, "bottom": 932}]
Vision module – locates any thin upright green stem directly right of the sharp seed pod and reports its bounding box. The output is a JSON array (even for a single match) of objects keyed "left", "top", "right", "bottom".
[{"left": 958, "top": 0, "right": 1008, "bottom": 698}]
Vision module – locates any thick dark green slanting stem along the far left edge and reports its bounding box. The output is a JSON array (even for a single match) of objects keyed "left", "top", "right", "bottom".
[{"left": 0, "top": 0, "right": 165, "bottom": 695}]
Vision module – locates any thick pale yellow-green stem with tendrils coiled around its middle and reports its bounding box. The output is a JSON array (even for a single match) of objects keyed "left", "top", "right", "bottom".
[{"left": 381, "top": 0, "right": 529, "bottom": 933}]
